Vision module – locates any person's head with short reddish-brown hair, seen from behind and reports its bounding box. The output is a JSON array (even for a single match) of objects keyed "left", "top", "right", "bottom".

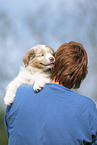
[{"left": 51, "top": 41, "right": 88, "bottom": 89}]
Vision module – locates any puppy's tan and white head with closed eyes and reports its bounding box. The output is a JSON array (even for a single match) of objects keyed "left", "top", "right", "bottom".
[{"left": 22, "top": 45, "right": 55, "bottom": 70}]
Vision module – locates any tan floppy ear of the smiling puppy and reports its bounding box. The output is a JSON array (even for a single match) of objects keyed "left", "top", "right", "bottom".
[{"left": 22, "top": 49, "right": 35, "bottom": 67}]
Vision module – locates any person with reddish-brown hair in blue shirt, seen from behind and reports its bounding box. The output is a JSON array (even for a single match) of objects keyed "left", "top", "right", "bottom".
[{"left": 5, "top": 41, "right": 97, "bottom": 145}]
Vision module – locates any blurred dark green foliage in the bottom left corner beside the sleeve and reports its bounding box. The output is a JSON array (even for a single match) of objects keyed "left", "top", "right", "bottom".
[{"left": 0, "top": 111, "right": 8, "bottom": 145}]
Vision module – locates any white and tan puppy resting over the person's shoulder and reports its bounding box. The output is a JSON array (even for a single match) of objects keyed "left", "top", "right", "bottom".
[{"left": 4, "top": 45, "right": 55, "bottom": 105}]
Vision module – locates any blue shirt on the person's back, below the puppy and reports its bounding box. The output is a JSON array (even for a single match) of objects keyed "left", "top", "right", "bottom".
[{"left": 5, "top": 83, "right": 97, "bottom": 145}]
